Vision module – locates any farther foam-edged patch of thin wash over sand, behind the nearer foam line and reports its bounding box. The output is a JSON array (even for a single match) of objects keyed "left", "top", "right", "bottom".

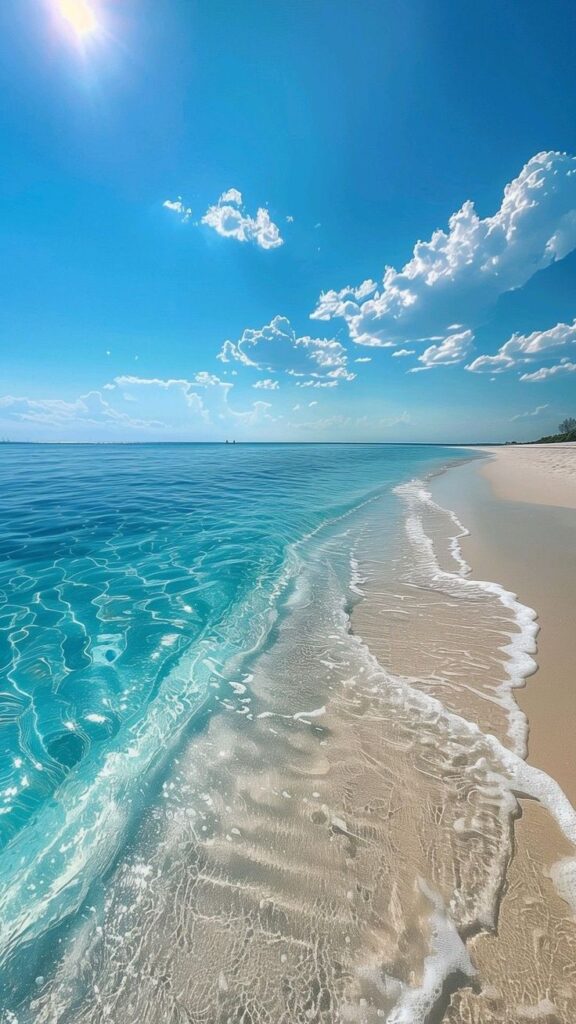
[{"left": 354, "top": 484, "right": 537, "bottom": 755}]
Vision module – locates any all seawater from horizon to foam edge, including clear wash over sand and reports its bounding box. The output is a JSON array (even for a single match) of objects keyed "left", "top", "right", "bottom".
[{"left": 0, "top": 445, "right": 569, "bottom": 1024}]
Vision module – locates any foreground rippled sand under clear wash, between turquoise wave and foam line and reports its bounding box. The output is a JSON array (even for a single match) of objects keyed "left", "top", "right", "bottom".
[{"left": 22, "top": 489, "right": 575, "bottom": 1024}]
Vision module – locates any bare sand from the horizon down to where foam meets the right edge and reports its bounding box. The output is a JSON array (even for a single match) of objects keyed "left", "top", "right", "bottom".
[{"left": 430, "top": 444, "right": 576, "bottom": 805}]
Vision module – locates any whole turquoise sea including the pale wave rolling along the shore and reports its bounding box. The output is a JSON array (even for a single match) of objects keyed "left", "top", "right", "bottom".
[{"left": 0, "top": 444, "right": 463, "bottom": 1005}]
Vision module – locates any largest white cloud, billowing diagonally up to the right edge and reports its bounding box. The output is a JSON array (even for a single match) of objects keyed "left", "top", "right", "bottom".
[{"left": 312, "top": 153, "right": 576, "bottom": 346}]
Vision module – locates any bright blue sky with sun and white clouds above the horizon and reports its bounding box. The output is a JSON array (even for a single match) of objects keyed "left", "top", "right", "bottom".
[{"left": 0, "top": 0, "right": 576, "bottom": 442}]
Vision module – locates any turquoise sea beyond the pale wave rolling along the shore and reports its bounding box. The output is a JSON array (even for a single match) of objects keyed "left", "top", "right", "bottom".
[{"left": 0, "top": 445, "right": 455, "bottom": 846}]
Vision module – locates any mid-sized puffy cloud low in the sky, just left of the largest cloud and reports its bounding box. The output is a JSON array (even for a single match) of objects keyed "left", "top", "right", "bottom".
[{"left": 216, "top": 316, "right": 356, "bottom": 387}]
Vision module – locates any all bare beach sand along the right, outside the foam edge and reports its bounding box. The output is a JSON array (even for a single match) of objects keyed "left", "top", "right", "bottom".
[{"left": 433, "top": 445, "right": 576, "bottom": 1024}]
